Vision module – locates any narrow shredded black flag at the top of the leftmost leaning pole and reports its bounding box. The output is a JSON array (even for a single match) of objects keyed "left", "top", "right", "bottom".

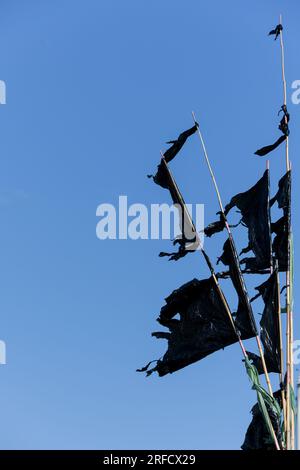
[{"left": 149, "top": 158, "right": 200, "bottom": 261}]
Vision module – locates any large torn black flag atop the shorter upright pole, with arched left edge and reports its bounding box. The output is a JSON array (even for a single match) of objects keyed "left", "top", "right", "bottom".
[{"left": 225, "top": 170, "right": 271, "bottom": 273}]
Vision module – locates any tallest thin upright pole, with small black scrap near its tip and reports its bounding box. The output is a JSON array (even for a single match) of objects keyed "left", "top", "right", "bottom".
[{"left": 279, "top": 15, "right": 295, "bottom": 450}]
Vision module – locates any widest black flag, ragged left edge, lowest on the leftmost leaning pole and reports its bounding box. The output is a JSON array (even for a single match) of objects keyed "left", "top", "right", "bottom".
[{"left": 139, "top": 277, "right": 238, "bottom": 377}]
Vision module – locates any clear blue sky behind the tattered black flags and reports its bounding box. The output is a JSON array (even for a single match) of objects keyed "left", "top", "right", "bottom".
[{"left": 0, "top": 0, "right": 300, "bottom": 449}]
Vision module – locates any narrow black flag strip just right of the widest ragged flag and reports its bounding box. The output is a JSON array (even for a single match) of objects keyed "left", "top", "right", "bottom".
[{"left": 218, "top": 238, "right": 257, "bottom": 339}]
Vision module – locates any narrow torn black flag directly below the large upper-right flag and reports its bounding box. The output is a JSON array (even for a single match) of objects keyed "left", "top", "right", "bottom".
[{"left": 249, "top": 270, "right": 281, "bottom": 374}]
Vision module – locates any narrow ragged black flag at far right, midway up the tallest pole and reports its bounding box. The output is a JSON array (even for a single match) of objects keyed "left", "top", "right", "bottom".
[{"left": 270, "top": 171, "right": 292, "bottom": 271}]
